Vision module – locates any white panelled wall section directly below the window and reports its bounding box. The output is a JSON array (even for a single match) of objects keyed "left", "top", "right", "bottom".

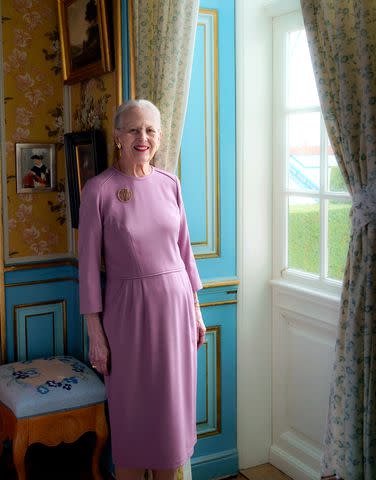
[{"left": 270, "top": 287, "right": 339, "bottom": 480}]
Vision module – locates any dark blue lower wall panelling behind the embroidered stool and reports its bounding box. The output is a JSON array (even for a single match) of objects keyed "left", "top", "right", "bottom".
[{"left": 5, "top": 264, "right": 84, "bottom": 362}]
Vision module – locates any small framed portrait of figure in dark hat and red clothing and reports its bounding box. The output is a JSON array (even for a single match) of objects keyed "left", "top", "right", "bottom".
[{"left": 16, "top": 143, "right": 56, "bottom": 193}]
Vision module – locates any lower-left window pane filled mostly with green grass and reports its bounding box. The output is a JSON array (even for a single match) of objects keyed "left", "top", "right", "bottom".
[{"left": 288, "top": 196, "right": 320, "bottom": 274}]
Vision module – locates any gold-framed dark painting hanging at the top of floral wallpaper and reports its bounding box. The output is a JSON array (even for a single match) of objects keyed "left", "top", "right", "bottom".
[{"left": 58, "top": 0, "right": 113, "bottom": 84}]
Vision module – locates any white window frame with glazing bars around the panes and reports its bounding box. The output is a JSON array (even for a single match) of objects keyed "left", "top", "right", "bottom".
[{"left": 273, "top": 11, "right": 350, "bottom": 296}]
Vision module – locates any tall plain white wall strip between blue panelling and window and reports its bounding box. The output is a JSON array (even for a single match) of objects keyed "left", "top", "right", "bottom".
[{"left": 235, "top": 0, "right": 272, "bottom": 468}]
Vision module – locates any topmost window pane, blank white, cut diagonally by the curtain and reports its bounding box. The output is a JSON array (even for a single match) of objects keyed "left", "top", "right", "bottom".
[{"left": 287, "top": 29, "right": 319, "bottom": 108}]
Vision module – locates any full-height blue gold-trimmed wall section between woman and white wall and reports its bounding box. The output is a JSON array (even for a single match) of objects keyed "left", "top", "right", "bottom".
[{"left": 179, "top": 0, "right": 238, "bottom": 480}]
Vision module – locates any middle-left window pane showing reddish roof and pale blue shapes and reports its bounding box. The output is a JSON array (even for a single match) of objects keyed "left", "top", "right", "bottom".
[{"left": 288, "top": 112, "right": 320, "bottom": 191}]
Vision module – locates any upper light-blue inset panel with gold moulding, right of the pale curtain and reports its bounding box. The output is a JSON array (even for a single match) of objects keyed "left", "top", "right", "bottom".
[{"left": 179, "top": 9, "right": 220, "bottom": 258}]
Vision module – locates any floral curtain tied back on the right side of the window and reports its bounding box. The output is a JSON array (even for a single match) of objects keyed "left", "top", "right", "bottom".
[{"left": 301, "top": 0, "right": 376, "bottom": 480}]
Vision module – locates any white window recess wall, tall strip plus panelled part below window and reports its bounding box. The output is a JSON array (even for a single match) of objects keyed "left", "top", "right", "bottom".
[{"left": 235, "top": 0, "right": 339, "bottom": 480}]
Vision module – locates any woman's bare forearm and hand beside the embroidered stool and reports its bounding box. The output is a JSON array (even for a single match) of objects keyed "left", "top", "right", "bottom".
[{"left": 85, "top": 313, "right": 110, "bottom": 375}]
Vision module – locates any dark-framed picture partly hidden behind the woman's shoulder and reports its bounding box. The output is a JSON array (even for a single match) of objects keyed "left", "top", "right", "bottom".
[{"left": 64, "top": 130, "right": 107, "bottom": 228}]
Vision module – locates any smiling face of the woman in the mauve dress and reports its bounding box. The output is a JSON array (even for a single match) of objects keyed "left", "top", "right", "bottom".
[{"left": 115, "top": 107, "right": 161, "bottom": 165}]
